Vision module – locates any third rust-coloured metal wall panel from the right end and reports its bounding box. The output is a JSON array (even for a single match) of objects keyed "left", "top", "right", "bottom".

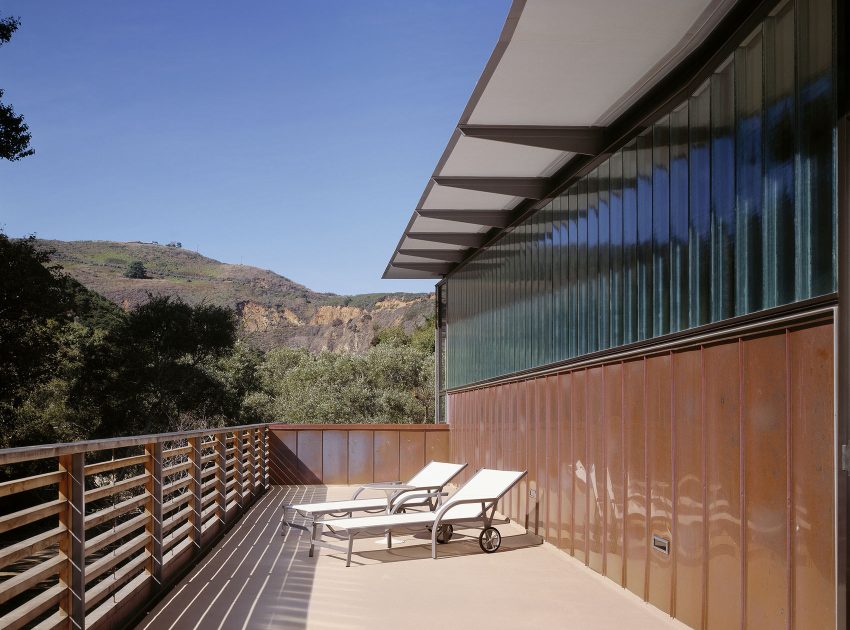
[{"left": 703, "top": 343, "right": 743, "bottom": 630}]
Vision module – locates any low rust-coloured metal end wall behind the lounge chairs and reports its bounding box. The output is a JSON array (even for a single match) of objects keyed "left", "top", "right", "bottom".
[{"left": 269, "top": 424, "right": 449, "bottom": 485}]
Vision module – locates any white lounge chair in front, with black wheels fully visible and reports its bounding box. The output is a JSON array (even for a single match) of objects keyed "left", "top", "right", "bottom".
[{"left": 310, "top": 468, "right": 526, "bottom": 567}]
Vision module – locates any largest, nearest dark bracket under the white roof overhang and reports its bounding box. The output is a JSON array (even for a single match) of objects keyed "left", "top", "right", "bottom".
[{"left": 458, "top": 125, "right": 606, "bottom": 155}]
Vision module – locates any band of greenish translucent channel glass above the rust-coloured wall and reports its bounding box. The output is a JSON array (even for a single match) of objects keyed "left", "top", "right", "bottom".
[{"left": 441, "top": 0, "right": 837, "bottom": 387}]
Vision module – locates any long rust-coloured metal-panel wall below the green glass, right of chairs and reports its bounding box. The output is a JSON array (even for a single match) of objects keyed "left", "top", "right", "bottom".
[{"left": 450, "top": 321, "right": 836, "bottom": 630}]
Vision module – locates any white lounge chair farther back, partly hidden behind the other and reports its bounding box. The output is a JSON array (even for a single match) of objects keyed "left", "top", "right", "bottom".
[{"left": 284, "top": 462, "right": 466, "bottom": 532}]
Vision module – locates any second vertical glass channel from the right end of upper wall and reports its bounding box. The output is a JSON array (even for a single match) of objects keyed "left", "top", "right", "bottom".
[{"left": 763, "top": 2, "right": 797, "bottom": 308}]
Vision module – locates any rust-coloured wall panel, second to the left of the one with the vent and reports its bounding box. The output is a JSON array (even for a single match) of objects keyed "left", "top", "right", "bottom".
[{"left": 599, "top": 363, "right": 625, "bottom": 585}]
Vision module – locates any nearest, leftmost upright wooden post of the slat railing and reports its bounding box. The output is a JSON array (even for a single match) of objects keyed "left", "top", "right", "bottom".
[{"left": 59, "top": 453, "right": 86, "bottom": 630}]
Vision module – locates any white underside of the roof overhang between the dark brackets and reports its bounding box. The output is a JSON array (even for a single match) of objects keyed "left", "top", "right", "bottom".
[{"left": 384, "top": 0, "right": 736, "bottom": 278}]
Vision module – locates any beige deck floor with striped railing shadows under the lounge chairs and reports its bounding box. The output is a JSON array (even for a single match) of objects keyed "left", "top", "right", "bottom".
[{"left": 137, "top": 486, "right": 686, "bottom": 630}]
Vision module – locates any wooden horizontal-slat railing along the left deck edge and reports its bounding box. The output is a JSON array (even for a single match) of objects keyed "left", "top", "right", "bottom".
[{"left": 0, "top": 425, "right": 268, "bottom": 629}]
